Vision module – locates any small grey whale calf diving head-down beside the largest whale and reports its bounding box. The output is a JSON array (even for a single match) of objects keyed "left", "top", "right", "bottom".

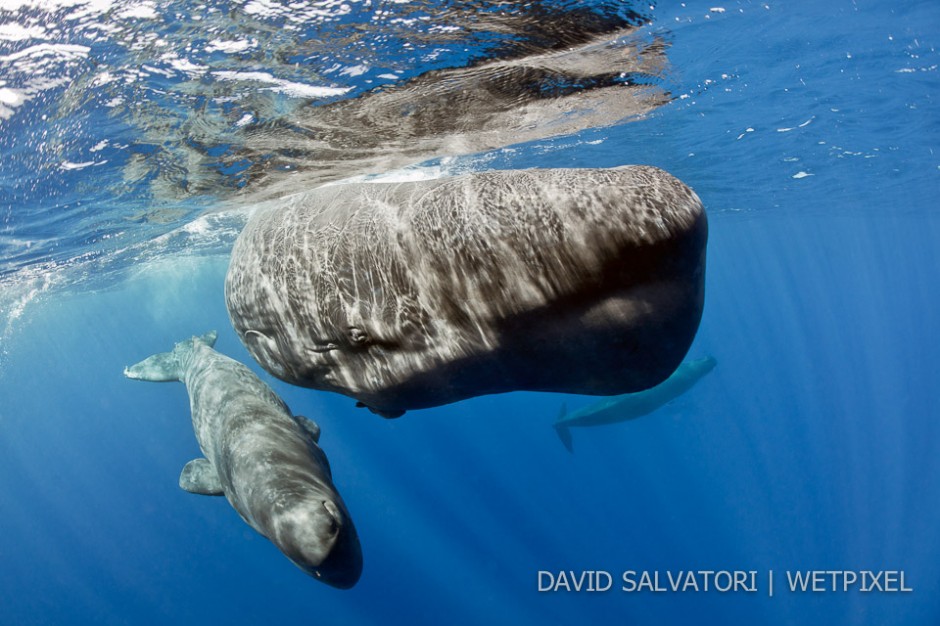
[{"left": 124, "top": 332, "right": 362, "bottom": 588}]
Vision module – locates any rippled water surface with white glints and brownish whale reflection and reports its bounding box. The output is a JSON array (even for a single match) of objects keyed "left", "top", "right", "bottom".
[{"left": 0, "top": 0, "right": 671, "bottom": 280}]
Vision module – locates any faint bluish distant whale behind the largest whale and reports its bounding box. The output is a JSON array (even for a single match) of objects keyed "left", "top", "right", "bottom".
[{"left": 554, "top": 357, "right": 716, "bottom": 452}]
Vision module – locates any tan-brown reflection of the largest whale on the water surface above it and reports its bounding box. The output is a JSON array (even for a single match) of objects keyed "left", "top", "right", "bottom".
[{"left": 243, "top": 28, "right": 670, "bottom": 197}]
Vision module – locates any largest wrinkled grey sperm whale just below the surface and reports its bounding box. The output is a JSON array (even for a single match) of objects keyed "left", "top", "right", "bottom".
[{"left": 225, "top": 166, "right": 707, "bottom": 417}]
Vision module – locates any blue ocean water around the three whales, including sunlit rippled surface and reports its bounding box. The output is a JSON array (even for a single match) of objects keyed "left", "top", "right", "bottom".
[{"left": 0, "top": 0, "right": 940, "bottom": 624}]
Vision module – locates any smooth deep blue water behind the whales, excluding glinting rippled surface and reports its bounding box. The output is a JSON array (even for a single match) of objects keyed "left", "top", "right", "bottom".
[{"left": 0, "top": 1, "right": 940, "bottom": 624}]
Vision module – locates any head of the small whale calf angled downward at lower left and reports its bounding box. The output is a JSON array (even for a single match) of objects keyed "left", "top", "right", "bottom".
[{"left": 271, "top": 498, "right": 362, "bottom": 589}]
